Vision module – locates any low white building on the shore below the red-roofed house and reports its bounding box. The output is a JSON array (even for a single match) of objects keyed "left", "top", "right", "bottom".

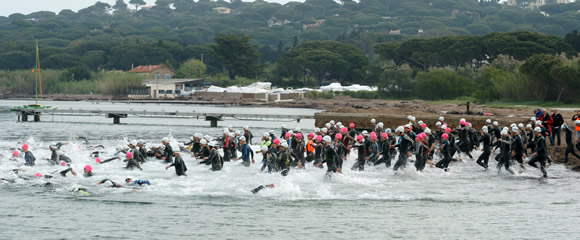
[{"left": 138, "top": 78, "right": 211, "bottom": 98}]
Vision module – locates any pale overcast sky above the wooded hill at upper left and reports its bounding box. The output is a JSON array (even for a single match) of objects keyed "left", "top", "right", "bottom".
[{"left": 0, "top": 0, "right": 294, "bottom": 16}]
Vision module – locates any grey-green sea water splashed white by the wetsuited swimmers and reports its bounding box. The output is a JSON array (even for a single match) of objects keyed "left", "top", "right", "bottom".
[{"left": 0, "top": 101, "right": 580, "bottom": 239}]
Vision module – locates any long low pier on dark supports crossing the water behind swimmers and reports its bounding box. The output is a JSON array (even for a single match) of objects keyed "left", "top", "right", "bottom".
[{"left": 14, "top": 109, "right": 314, "bottom": 127}]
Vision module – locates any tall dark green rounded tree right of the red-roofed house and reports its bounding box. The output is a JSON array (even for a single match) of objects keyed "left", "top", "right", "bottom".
[{"left": 212, "top": 34, "right": 260, "bottom": 80}]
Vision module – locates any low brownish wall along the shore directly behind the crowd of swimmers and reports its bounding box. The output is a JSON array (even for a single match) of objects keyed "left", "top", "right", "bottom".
[{"left": 314, "top": 112, "right": 530, "bottom": 130}]
